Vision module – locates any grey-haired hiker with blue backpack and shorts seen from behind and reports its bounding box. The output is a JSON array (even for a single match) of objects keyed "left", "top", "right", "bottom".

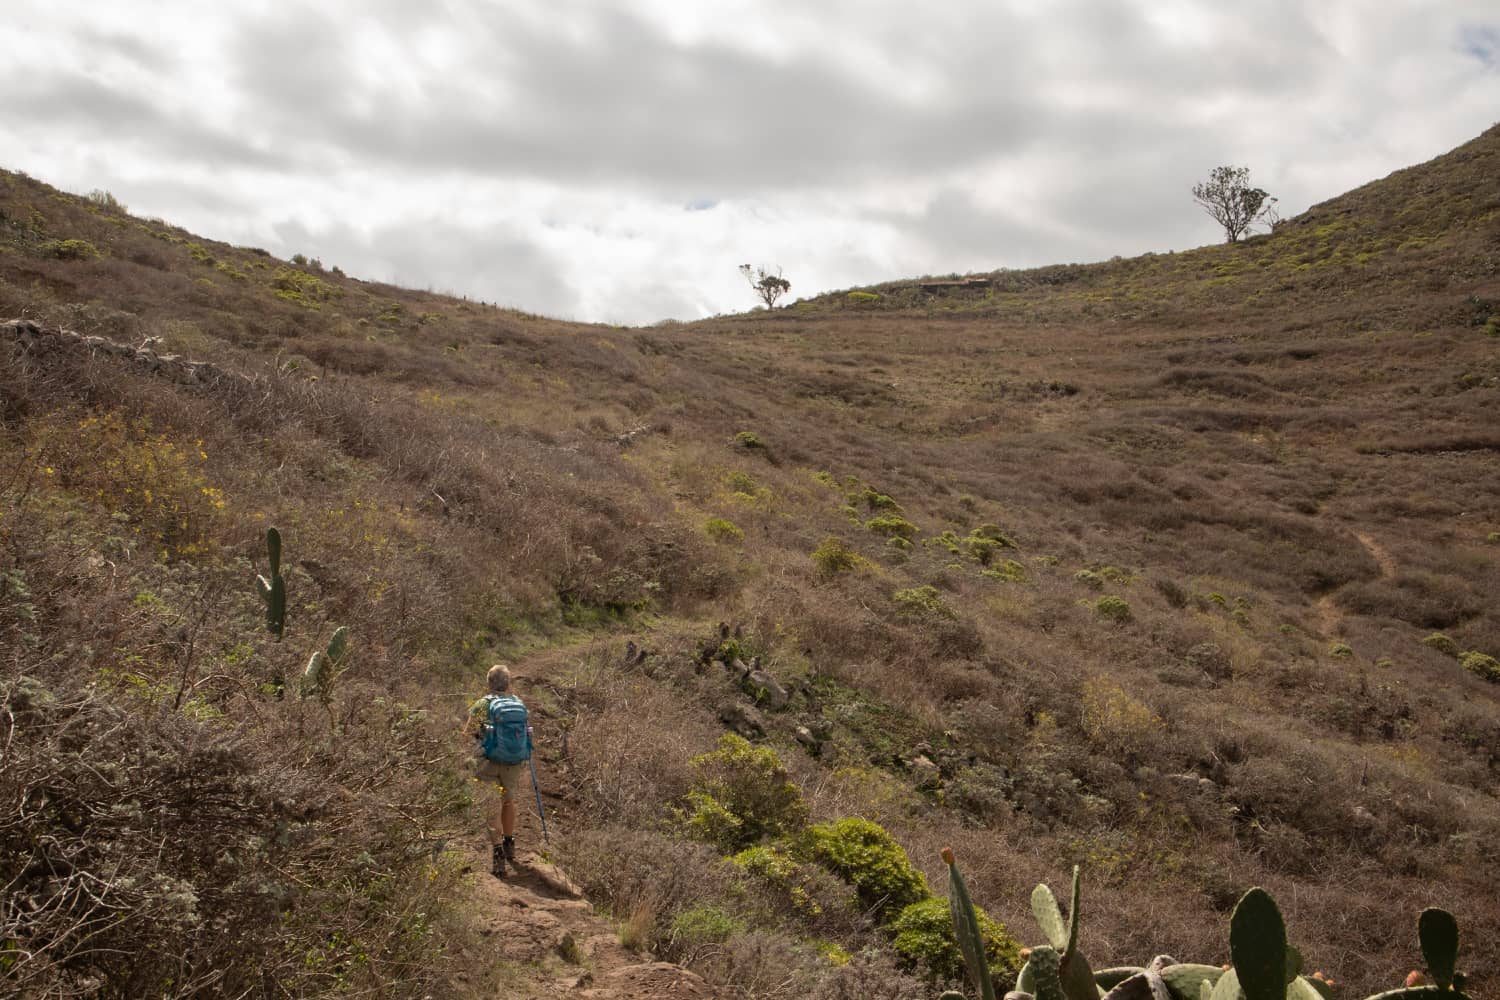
[{"left": 465, "top": 663, "right": 531, "bottom": 879}]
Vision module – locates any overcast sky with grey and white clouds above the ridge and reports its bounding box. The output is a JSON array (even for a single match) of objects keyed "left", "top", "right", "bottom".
[{"left": 11, "top": 0, "right": 1500, "bottom": 324}]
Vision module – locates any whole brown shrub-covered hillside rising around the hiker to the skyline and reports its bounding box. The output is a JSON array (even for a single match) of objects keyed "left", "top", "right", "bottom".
[{"left": 0, "top": 127, "right": 1500, "bottom": 997}]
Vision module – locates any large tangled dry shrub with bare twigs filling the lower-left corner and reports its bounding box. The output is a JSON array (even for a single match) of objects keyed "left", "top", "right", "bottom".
[{"left": 0, "top": 676, "right": 455, "bottom": 997}]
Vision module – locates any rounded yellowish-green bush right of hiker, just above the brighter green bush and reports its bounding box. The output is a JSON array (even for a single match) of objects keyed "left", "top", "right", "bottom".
[{"left": 686, "top": 733, "right": 807, "bottom": 853}]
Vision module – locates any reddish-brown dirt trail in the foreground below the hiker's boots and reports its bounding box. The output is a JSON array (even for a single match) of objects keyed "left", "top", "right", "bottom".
[{"left": 470, "top": 850, "right": 723, "bottom": 1000}]
